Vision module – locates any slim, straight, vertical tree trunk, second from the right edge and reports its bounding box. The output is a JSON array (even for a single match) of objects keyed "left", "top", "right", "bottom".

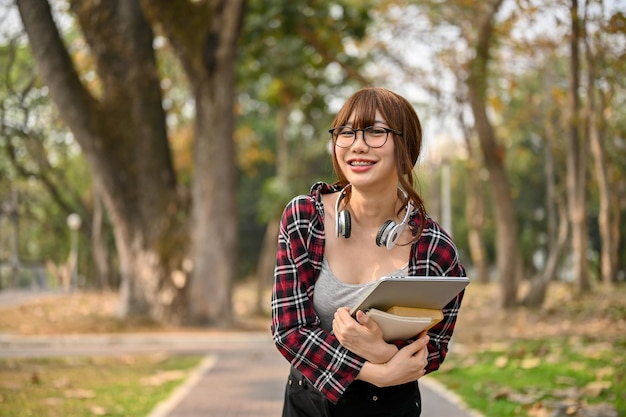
[{"left": 567, "top": 0, "right": 591, "bottom": 292}]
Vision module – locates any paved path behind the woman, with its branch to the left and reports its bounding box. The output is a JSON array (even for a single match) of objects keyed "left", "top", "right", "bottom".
[{"left": 0, "top": 292, "right": 479, "bottom": 417}]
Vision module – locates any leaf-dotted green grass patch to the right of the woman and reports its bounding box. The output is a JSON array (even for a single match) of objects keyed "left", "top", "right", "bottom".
[{"left": 433, "top": 337, "right": 626, "bottom": 417}]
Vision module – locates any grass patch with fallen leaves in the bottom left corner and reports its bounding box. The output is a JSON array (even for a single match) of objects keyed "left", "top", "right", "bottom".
[{"left": 0, "top": 355, "right": 202, "bottom": 417}]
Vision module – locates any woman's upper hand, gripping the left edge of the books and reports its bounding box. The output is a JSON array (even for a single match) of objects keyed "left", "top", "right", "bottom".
[{"left": 333, "top": 307, "right": 398, "bottom": 363}]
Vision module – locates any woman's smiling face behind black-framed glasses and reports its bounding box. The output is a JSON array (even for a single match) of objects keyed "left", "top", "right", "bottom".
[{"left": 335, "top": 111, "right": 398, "bottom": 187}]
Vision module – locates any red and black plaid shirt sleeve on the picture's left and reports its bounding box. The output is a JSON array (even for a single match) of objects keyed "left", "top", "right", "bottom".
[{"left": 271, "top": 196, "right": 364, "bottom": 402}]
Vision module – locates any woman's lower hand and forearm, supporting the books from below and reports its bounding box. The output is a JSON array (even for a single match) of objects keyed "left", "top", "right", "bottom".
[{"left": 357, "top": 335, "right": 429, "bottom": 387}]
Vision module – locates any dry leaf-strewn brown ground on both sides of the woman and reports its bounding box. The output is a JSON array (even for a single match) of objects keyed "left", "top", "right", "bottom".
[{"left": 0, "top": 282, "right": 626, "bottom": 417}]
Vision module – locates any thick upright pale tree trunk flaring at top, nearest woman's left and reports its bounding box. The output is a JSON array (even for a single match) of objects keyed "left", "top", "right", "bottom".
[{"left": 142, "top": 0, "right": 245, "bottom": 326}]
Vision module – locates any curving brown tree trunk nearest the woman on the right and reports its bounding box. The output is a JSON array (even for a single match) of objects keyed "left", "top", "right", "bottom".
[{"left": 467, "top": 0, "right": 521, "bottom": 308}]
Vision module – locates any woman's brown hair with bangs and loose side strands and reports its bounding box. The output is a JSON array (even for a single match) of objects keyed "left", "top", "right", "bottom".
[{"left": 332, "top": 87, "right": 426, "bottom": 239}]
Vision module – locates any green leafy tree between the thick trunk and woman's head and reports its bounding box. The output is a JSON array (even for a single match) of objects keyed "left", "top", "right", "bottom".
[{"left": 238, "top": 0, "right": 374, "bottom": 310}]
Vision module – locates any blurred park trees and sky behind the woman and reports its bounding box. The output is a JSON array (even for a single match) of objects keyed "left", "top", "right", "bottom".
[{"left": 0, "top": 0, "right": 626, "bottom": 325}]
